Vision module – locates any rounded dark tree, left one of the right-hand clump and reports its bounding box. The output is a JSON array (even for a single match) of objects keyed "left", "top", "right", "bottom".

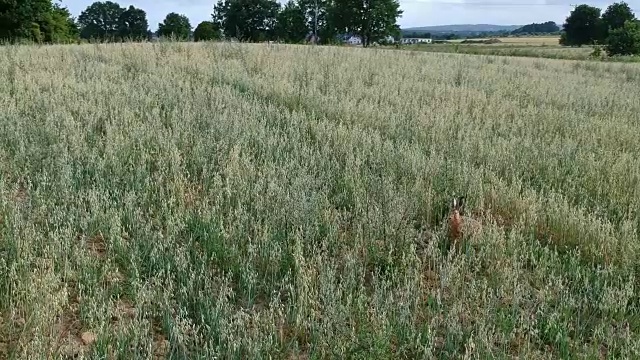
[{"left": 561, "top": 4, "right": 602, "bottom": 46}]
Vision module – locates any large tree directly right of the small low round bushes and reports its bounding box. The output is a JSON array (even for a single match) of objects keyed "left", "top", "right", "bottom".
[{"left": 212, "top": 0, "right": 280, "bottom": 41}]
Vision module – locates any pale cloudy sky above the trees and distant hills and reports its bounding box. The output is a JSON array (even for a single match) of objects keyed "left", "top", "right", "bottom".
[{"left": 62, "top": 0, "right": 640, "bottom": 30}]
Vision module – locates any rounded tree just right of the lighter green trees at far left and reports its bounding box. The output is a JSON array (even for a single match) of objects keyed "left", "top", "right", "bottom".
[{"left": 78, "top": 1, "right": 125, "bottom": 40}]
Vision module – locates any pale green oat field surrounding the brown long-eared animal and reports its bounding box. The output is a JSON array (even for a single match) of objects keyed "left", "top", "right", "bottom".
[{"left": 0, "top": 43, "right": 640, "bottom": 359}]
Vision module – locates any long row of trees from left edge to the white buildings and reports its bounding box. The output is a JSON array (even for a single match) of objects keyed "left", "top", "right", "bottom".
[{"left": 0, "top": 0, "right": 402, "bottom": 46}]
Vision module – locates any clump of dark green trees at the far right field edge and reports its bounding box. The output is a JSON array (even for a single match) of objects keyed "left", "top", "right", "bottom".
[{"left": 560, "top": 1, "right": 640, "bottom": 56}]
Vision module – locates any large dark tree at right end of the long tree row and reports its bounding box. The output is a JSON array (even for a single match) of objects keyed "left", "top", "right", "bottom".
[{"left": 328, "top": 0, "right": 403, "bottom": 47}]
